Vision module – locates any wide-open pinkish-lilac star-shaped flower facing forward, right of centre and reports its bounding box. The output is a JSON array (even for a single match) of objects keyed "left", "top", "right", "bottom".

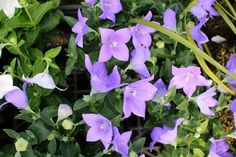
[{"left": 169, "top": 66, "right": 209, "bottom": 97}]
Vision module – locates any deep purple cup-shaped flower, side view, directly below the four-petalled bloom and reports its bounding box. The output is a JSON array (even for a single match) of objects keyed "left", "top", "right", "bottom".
[{"left": 85, "top": 54, "right": 124, "bottom": 93}]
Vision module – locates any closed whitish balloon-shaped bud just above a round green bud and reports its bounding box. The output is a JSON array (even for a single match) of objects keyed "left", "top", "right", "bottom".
[{"left": 57, "top": 104, "right": 73, "bottom": 121}]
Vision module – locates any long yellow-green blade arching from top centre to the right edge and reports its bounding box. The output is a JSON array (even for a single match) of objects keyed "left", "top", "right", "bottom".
[{"left": 130, "top": 19, "right": 236, "bottom": 80}]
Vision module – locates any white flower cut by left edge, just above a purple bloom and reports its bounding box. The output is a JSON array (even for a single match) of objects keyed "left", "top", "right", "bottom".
[{"left": 0, "top": 74, "right": 18, "bottom": 99}]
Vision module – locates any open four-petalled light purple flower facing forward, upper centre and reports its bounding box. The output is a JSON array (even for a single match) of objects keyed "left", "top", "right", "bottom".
[{"left": 98, "top": 28, "right": 131, "bottom": 62}]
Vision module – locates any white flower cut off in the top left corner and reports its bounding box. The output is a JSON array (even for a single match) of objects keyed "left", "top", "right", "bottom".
[{"left": 0, "top": 0, "right": 22, "bottom": 18}]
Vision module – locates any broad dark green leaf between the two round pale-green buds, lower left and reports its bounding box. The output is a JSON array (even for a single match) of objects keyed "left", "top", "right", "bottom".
[{"left": 29, "top": 120, "right": 51, "bottom": 143}]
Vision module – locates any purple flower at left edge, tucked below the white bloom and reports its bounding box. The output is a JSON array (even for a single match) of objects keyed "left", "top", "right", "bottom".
[{"left": 0, "top": 82, "right": 28, "bottom": 109}]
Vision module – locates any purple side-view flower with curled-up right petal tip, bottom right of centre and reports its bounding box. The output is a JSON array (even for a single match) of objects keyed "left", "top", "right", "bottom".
[{"left": 149, "top": 118, "right": 184, "bottom": 150}]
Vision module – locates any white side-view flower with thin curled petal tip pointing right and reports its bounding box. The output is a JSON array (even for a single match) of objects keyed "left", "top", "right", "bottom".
[{"left": 22, "top": 71, "right": 64, "bottom": 90}]
